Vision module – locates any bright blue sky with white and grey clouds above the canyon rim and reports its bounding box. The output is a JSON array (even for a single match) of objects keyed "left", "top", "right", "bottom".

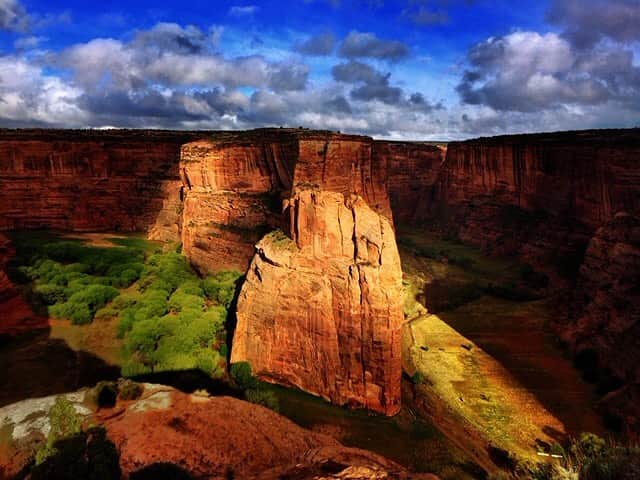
[{"left": 0, "top": 0, "right": 640, "bottom": 140}]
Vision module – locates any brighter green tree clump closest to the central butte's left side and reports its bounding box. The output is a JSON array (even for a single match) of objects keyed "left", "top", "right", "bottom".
[{"left": 118, "top": 252, "right": 240, "bottom": 378}]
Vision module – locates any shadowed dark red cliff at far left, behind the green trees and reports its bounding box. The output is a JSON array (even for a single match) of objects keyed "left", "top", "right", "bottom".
[{"left": 0, "top": 131, "right": 201, "bottom": 239}]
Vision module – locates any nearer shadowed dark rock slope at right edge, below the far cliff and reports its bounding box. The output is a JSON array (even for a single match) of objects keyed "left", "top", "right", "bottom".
[{"left": 554, "top": 213, "right": 640, "bottom": 433}]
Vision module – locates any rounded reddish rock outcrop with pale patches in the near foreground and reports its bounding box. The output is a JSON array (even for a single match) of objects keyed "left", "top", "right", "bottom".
[{"left": 0, "top": 384, "right": 435, "bottom": 480}]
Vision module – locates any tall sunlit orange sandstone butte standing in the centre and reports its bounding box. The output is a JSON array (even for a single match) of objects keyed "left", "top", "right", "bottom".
[{"left": 231, "top": 136, "right": 403, "bottom": 415}]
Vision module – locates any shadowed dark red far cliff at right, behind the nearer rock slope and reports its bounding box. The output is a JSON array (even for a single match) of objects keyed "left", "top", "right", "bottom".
[{"left": 430, "top": 130, "right": 640, "bottom": 282}]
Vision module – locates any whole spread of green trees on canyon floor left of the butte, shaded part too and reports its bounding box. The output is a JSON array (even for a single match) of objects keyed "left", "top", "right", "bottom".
[{"left": 12, "top": 233, "right": 241, "bottom": 380}]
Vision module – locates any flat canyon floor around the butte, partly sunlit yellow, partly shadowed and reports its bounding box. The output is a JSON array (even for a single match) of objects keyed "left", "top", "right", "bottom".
[{"left": 0, "top": 230, "right": 606, "bottom": 479}]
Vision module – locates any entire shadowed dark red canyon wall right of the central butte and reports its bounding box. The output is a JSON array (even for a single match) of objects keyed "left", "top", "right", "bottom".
[{"left": 402, "top": 129, "right": 640, "bottom": 432}]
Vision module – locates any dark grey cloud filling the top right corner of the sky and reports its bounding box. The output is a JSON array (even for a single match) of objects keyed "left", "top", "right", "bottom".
[{"left": 547, "top": 0, "right": 640, "bottom": 48}]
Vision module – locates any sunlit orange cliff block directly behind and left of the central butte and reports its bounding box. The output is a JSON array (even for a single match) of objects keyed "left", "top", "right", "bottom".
[{"left": 180, "top": 136, "right": 297, "bottom": 271}]
